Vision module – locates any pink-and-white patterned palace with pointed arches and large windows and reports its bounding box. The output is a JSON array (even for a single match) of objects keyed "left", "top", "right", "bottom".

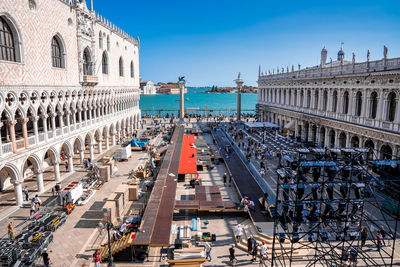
[{"left": 0, "top": 0, "right": 140, "bottom": 205}]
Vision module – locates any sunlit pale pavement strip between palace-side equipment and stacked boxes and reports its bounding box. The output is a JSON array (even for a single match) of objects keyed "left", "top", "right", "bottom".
[{"left": 48, "top": 152, "right": 148, "bottom": 266}]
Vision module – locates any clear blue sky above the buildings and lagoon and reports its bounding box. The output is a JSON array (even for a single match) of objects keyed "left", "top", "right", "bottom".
[{"left": 92, "top": 0, "right": 400, "bottom": 86}]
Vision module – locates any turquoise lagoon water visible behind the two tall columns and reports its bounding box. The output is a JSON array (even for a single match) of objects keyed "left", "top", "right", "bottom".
[{"left": 139, "top": 88, "right": 257, "bottom": 115}]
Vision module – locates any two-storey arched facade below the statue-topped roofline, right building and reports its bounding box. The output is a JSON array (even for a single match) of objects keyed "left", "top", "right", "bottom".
[{"left": 258, "top": 72, "right": 400, "bottom": 161}]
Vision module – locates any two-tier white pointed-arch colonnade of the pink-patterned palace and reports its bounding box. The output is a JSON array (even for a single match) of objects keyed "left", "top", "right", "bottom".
[{"left": 0, "top": 87, "right": 141, "bottom": 205}]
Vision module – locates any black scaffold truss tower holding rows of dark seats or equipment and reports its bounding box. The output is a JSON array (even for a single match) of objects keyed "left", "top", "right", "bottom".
[{"left": 271, "top": 148, "right": 400, "bottom": 267}]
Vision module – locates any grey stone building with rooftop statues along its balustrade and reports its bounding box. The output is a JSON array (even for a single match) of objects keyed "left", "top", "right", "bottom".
[{"left": 257, "top": 46, "right": 400, "bottom": 158}]
